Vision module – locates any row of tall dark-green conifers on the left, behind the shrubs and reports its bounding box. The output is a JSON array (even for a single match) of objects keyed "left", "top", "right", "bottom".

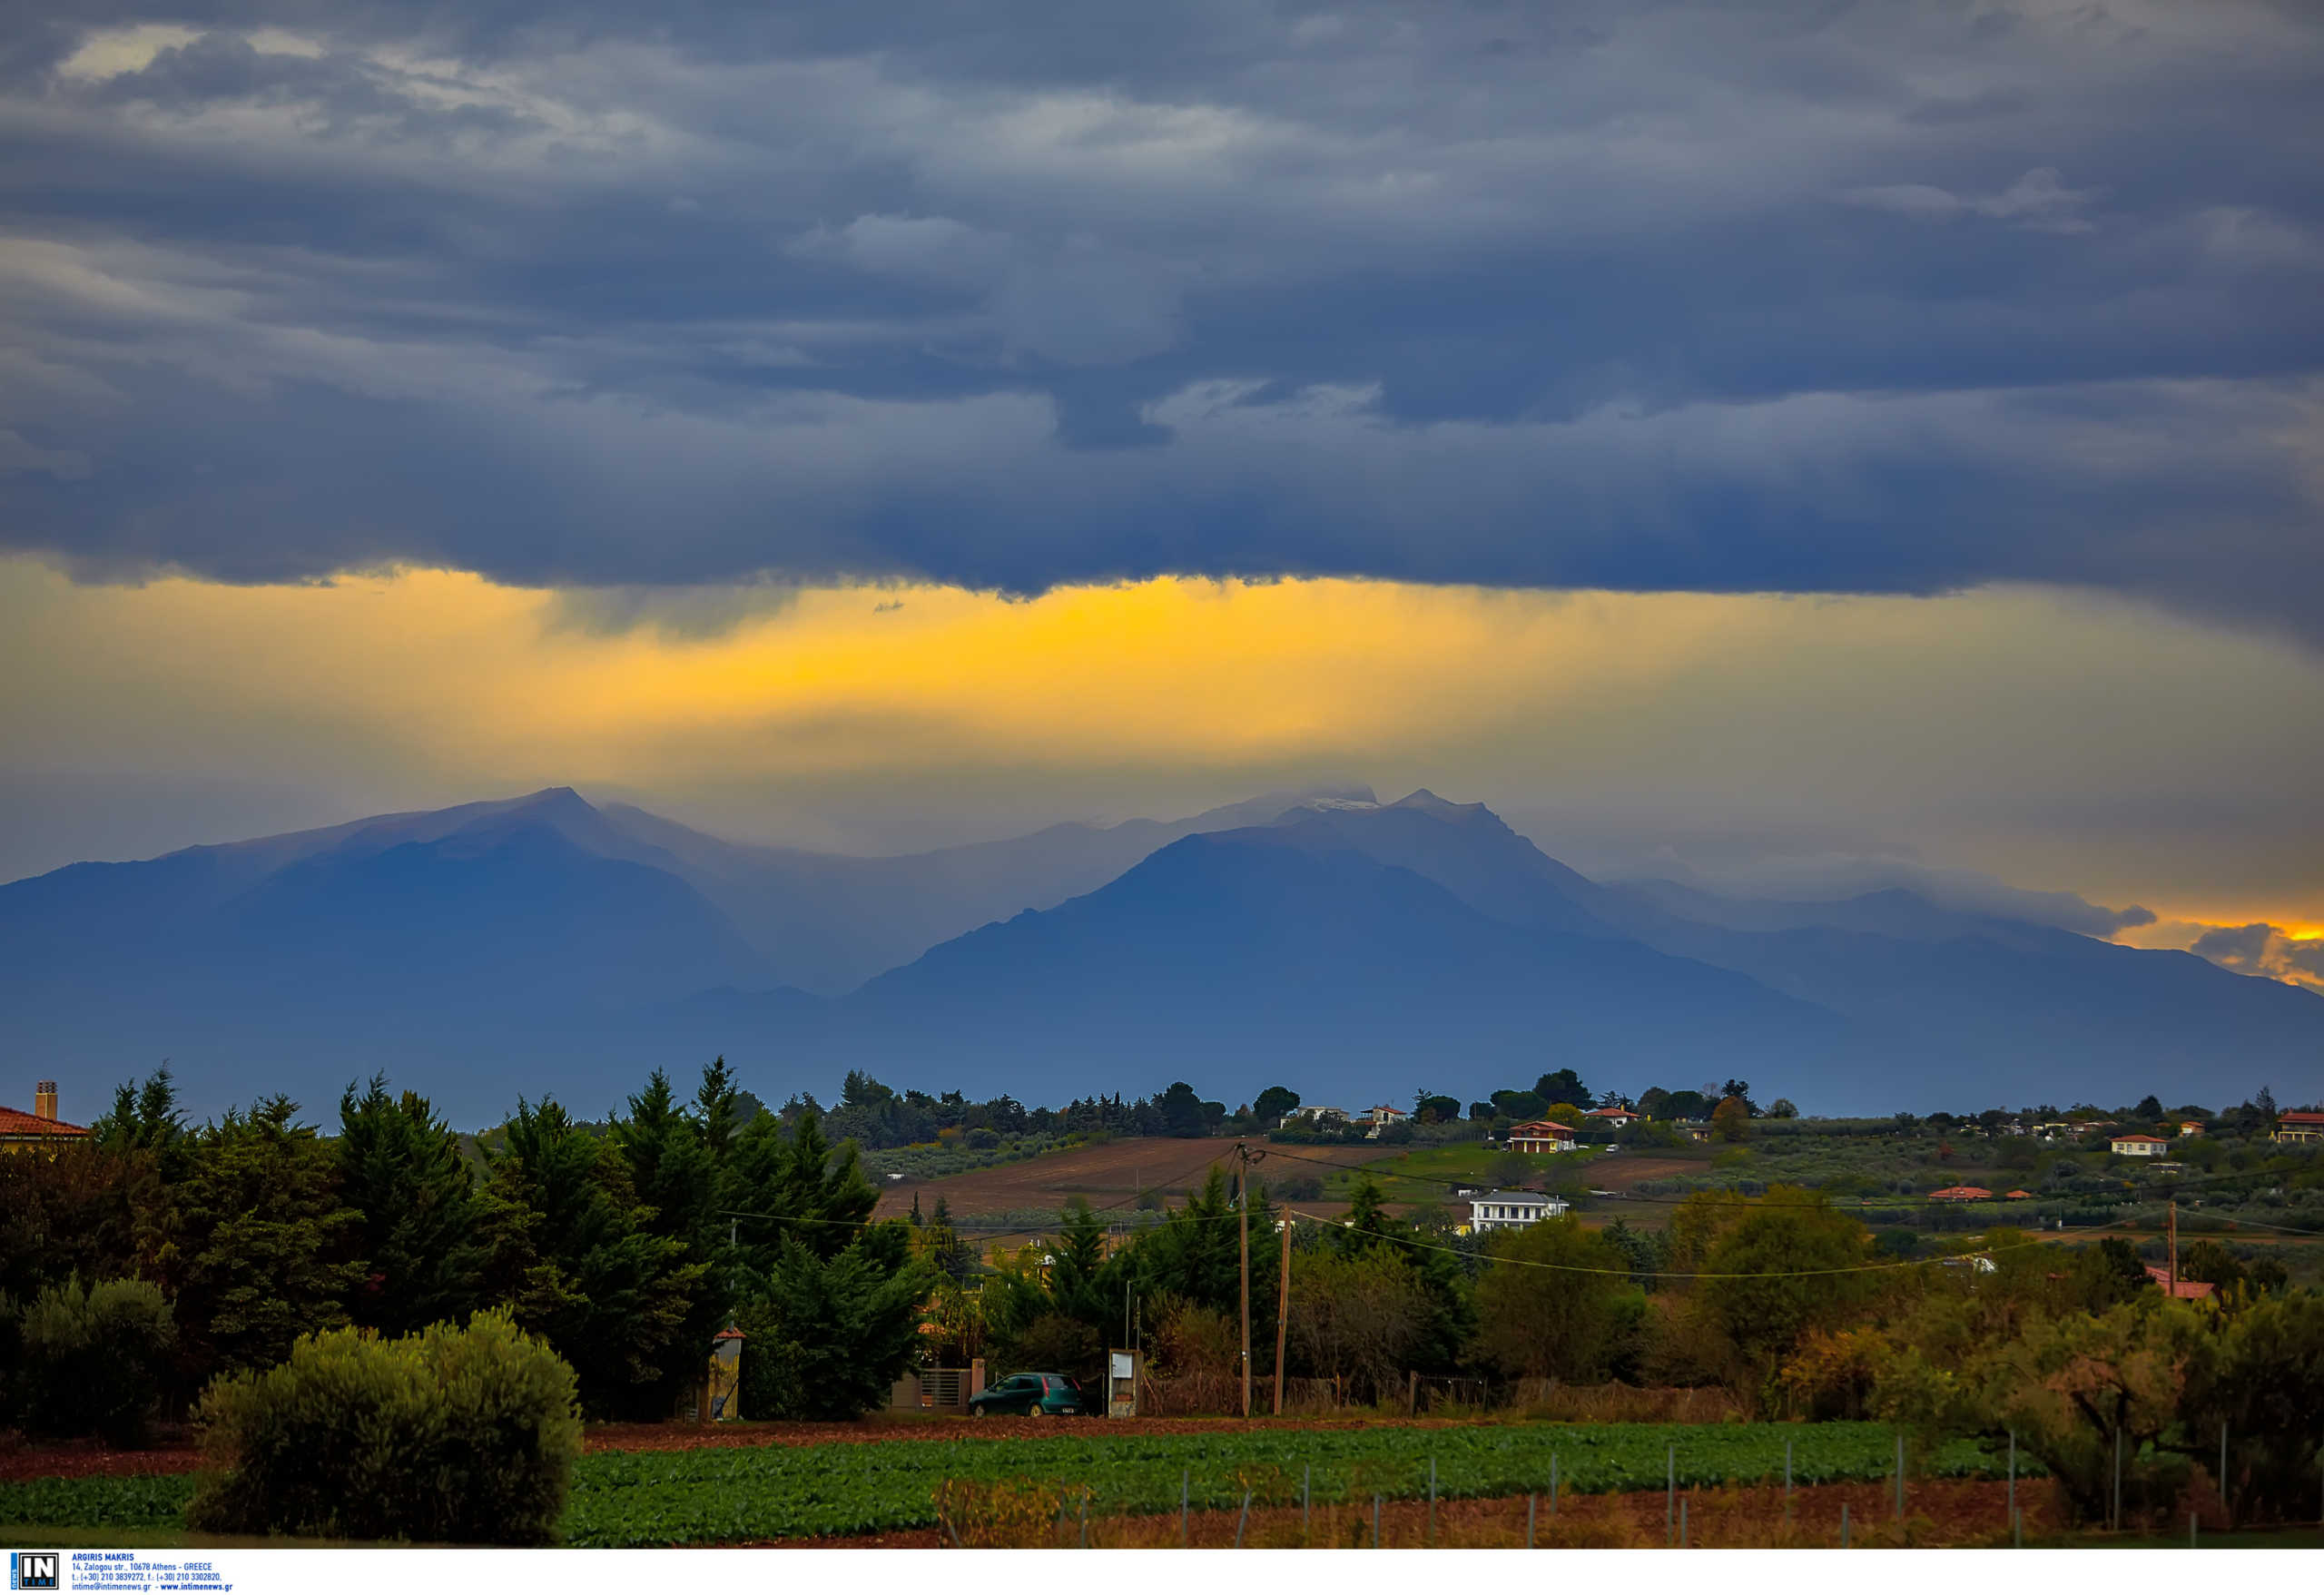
[{"left": 0, "top": 1060, "right": 934, "bottom": 1418}]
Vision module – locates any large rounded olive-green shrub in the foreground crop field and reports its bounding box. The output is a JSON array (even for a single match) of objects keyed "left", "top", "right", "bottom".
[{"left": 186, "top": 1312, "right": 581, "bottom": 1544}]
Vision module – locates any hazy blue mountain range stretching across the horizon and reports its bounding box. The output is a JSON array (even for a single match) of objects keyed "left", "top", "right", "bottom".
[{"left": 0, "top": 788, "right": 2324, "bottom": 1123}]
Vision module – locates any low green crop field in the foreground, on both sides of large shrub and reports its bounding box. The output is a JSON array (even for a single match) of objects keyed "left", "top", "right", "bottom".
[{"left": 0, "top": 1423, "right": 2031, "bottom": 1546}]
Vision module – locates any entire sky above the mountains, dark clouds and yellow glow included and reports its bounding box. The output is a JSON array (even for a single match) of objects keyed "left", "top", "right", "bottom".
[{"left": 0, "top": 0, "right": 2324, "bottom": 999}]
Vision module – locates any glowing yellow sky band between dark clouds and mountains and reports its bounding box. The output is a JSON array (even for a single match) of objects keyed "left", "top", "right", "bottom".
[{"left": 0, "top": 548, "right": 2324, "bottom": 976}]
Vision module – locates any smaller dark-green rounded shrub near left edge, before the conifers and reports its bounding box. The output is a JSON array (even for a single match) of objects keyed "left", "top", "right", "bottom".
[{"left": 16, "top": 1276, "right": 177, "bottom": 1446}]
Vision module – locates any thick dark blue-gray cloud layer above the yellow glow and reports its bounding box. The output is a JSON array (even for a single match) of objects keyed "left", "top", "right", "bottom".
[{"left": 0, "top": 0, "right": 2324, "bottom": 642}]
